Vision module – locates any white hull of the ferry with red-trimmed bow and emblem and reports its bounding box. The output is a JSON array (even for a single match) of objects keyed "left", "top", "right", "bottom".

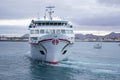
[{"left": 31, "top": 35, "right": 72, "bottom": 63}]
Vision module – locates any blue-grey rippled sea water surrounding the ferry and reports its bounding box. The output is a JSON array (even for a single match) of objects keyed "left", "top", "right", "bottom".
[{"left": 0, "top": 42, "right": 120, "bottom": 80}]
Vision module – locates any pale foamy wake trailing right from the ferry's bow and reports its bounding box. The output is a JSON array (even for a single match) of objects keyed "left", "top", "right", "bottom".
[{"left": 25, "top": 52, "right": 120, "bottom": 74}]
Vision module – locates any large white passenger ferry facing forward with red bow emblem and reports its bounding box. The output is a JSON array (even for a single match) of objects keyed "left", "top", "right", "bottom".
[{"left": 29, "top": 6, "right": 75, "bottom": 64}]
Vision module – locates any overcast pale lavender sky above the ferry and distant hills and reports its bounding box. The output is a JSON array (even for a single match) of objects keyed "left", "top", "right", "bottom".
[{"left": 0, "top": 0, "right": 120, "bottom": 35}]
